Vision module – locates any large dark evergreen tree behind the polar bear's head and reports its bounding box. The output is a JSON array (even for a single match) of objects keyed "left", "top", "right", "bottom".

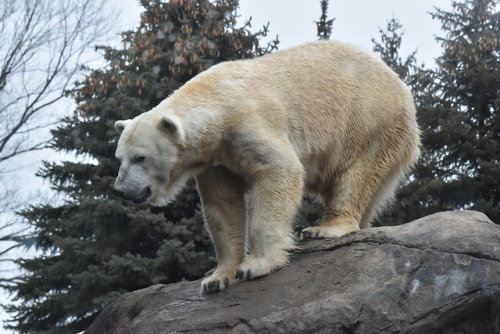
[{"left": 2, "top": 0, "right": 278, "bottom": 333}]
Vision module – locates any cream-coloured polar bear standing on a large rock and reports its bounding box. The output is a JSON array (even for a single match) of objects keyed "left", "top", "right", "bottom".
[{"left": 114, "top": 41, "right": 420, "bottom": 293}]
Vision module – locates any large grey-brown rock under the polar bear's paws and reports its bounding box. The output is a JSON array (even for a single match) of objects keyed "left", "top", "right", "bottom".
[{"left": 85, "top": 211, "right": 500, "bottom": 334}]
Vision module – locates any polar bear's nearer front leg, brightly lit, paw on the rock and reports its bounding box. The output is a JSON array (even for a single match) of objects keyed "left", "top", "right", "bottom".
[{"left": 236, "top": 145, "right": 303, "bottom": 279}]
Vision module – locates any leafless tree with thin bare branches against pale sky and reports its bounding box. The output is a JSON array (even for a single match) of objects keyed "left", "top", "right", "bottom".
[{"left": 0, "top": 0, "right": 114, "bottom": 274}]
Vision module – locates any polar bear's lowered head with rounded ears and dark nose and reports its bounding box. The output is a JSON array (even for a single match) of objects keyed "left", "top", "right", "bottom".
[{"left": 113, "top": 113, "right": 190, "bottom": 206}]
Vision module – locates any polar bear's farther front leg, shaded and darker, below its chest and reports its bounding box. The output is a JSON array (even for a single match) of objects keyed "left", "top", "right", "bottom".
[{"left": 196, "top": 167, "right": 246, "bottom": 293}]
